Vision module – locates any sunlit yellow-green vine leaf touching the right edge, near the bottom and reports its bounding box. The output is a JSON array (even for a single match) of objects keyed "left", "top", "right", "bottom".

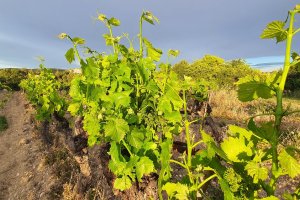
[{"left": 278, "top": 150, "right": 300, "bottom": 178}]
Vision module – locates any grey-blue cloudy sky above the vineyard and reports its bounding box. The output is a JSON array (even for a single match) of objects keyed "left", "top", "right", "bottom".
[{"left": 0, "top": 0, "right": 299, "bottom": 69}]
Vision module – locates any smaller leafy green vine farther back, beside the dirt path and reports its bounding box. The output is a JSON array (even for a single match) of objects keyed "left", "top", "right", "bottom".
[{"left": 20, "top": 65, "right": 66, "bottom": 120}]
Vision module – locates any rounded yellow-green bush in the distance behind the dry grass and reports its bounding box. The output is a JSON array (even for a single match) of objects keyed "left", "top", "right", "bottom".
[{"left": 173, "top": 55, "right": 262, "bottom": 88}]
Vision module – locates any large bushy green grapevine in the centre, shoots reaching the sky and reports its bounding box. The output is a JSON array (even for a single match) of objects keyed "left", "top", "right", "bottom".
[{"left": 60, "top": 12, "right": 211, "bottom": 197}]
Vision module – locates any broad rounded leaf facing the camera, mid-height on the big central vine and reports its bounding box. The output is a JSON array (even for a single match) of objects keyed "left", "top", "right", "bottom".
[{"left": 104, "top": 119, "right": 129, "bottom": 142}]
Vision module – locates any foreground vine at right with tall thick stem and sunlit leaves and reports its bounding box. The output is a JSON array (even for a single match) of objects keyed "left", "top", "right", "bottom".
[{"left": 204, "top": 5, "right": 300, "bottom": 199}]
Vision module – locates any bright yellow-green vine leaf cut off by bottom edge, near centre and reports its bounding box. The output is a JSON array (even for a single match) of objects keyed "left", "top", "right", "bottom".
[{"left": 162, "top": 183, "right": 189, "bottom": 200}]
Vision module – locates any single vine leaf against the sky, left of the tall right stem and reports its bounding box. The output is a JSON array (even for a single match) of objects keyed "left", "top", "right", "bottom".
[{"left": 260, "top": 21, "right": 287, "bottom": 43}]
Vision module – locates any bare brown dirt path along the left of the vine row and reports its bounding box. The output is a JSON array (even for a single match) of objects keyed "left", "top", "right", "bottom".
[{"left": 0, "top": 91, "right": 52, "bottom": 200}]
